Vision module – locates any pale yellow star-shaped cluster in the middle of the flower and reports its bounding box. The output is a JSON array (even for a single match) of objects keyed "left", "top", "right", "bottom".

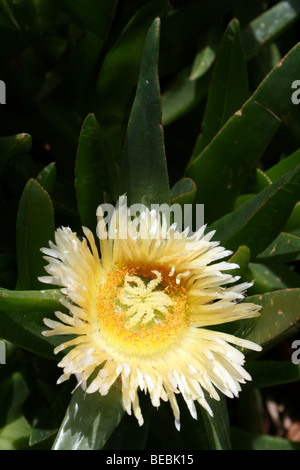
[{"left": 118, "top": 270, "right": 174, "bottom": 328}]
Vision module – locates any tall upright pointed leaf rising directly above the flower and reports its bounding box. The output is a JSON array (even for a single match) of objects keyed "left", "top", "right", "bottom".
[{"left": 120, "top": 18, "right": 170, "bottom": 206}]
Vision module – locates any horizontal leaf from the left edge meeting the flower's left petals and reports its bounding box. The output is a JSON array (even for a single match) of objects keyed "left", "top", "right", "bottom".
[{"left": 0, "top": 289, "right": 66, "bottom": 360}]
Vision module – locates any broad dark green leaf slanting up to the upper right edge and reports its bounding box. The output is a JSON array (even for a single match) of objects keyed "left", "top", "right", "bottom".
[{"left": 186, "top": 41, "right": 300, "bottom": 223}]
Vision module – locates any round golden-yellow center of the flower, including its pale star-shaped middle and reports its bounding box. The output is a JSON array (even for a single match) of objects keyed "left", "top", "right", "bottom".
[{"left": 97, "top": 266, "right": 189, "bottom": 356}]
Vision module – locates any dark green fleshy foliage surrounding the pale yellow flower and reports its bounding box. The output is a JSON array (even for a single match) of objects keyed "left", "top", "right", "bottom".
[{"left": 0, "top": 0, "right": 300, "bottom": 450}]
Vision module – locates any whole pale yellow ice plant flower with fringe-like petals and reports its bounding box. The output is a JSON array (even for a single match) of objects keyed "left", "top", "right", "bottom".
[{"left": 40, "top": 197, "right": 261, "bottom": 429}]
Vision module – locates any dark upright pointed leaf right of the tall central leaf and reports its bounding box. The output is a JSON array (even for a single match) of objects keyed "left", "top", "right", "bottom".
[{"left": 194, "top": 19, "right": 249, "bottom": 156}]
